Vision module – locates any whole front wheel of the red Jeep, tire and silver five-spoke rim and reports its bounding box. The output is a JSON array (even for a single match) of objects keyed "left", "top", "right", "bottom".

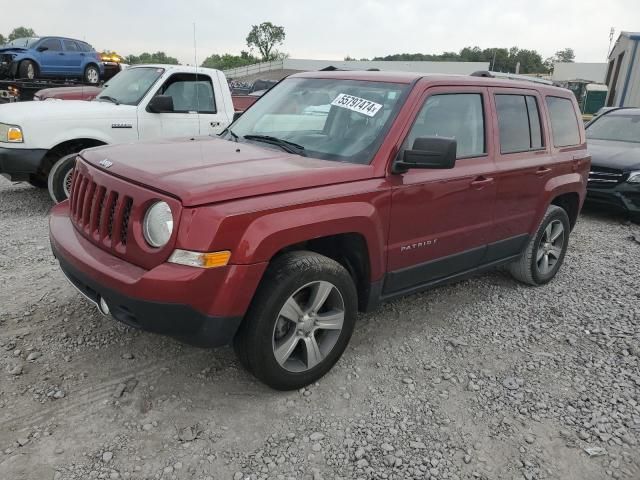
[{"left": 234, "top": 251, "right": 357, "bottom": 390}]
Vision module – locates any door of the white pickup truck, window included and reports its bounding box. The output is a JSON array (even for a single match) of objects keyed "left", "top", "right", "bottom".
[{"left": 138, "top": 73, "right": 228, "bottom": 139}]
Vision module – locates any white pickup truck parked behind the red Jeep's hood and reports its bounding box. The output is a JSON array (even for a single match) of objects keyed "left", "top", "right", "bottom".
[{"left": 0, "top": 65, "right": 234, "bottom": 202}]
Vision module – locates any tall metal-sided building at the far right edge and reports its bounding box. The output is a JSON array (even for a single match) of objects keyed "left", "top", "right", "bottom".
[{"left": 605, "top": 32, "right": 640, "bottom": 107}]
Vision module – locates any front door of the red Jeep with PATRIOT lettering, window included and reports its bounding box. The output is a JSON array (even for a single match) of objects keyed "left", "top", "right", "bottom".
[{"left": 383, "top": 86, "right": 496, "bottom": 296}]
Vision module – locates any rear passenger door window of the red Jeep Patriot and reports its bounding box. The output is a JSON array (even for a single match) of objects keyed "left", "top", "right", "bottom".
[{"left": 496, "top": 94, "right": 543, "bottom": 153}]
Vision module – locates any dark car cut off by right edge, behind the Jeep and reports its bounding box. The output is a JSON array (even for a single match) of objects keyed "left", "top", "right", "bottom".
[{"left": 586, "top": 108, "right": 640, "bottom": 221}]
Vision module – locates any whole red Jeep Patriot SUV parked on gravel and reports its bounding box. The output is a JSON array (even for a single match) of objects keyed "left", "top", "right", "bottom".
[{"left": 50, "top": 72, "right": 590, "bottom": 389}]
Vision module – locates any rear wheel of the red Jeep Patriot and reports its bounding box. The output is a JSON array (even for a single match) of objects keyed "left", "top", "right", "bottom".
[{"left": 510, "top": 205, "right": 571, "bottom": 286}]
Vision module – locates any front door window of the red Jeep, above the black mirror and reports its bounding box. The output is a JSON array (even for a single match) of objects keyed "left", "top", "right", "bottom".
[{"left": 405, "top": 93, "right": 487, "bottom": 158}]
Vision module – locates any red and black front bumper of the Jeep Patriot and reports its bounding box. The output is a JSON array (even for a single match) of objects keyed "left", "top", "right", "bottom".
[{"left": 49, "top": 202, "right": 266, "bottom": 347}]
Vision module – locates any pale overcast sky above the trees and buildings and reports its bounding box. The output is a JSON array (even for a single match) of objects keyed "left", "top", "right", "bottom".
[{"left": 0, "top": 0, "right": 640, "bottom": 64}]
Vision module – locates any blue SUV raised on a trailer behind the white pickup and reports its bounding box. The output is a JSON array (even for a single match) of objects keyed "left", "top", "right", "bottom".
[{"left": 0, "top": 37, "right": 104, "bottom": 84}]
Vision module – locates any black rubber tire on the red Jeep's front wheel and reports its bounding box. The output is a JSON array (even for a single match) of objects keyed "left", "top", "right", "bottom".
[{"left": 234, "top": 251, "right": 358, "bottom": 390}]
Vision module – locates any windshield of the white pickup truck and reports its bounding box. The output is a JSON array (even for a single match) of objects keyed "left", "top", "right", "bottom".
[{"left": 96, "top": 67, "right": 164, "bottom": 105}]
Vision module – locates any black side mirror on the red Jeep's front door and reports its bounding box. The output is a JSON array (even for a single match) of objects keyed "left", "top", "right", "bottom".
[{"left": 393, "top": 137, "right": 457, "bottom": 173}]
